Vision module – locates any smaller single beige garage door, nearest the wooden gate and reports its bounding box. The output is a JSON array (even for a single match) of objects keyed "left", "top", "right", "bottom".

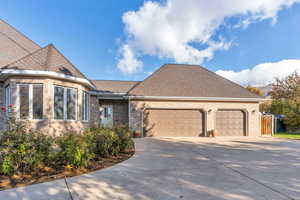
[{"left": 216, "top": 110, "right": 245, "bottom": 136}]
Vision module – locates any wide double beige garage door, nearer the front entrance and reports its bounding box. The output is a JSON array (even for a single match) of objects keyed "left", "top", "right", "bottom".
[{"left": 144, "top": 110, "right": 203, "bottom": 137}]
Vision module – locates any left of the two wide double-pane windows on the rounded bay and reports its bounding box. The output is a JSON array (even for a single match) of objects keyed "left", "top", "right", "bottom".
[{"left": 17, "top": 84, "right": 43, "bottom": 119}]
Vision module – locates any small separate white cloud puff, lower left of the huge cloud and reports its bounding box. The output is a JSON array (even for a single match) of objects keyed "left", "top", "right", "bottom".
[{"left": 117, "top": 44, "right": 143, "bottom": 74}]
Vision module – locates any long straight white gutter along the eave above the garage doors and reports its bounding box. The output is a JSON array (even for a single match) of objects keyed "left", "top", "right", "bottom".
[{"left": 128, "top": 96, "right": 266, "bottom": 102}]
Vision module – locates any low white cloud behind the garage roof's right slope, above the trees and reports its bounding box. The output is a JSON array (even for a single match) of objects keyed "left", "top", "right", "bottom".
[{"left": 216, "top": 59, "right": 300, "bottom": 86}]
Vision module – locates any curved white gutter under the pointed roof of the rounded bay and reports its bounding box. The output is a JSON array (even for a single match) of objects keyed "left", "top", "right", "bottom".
[{"left": 0, "top": 69, "right": 96, "bottom": 89}]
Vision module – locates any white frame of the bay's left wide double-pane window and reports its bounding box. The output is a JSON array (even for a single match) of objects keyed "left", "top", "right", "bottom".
[{"left": 16, "top": 83, "right": 44, "bottom": 121}]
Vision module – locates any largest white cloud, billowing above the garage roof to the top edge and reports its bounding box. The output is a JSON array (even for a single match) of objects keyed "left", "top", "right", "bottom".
[{"left": 119, "top": 0, "right": 300, "bottom": 74}]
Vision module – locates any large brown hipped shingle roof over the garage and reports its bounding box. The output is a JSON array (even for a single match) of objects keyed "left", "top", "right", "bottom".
[{"left": 129, "top": 64, "right": 258, "bottom": 98}]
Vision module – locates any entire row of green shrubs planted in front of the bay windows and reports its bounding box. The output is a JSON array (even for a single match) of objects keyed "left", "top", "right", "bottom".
[{"left": 0, "top": 126, "right": 134, "bottom": 175}]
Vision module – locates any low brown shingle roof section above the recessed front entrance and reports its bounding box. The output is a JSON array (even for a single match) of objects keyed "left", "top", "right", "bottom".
[{"left": 92, "top": 80, "right": 139, "bottom": 93}]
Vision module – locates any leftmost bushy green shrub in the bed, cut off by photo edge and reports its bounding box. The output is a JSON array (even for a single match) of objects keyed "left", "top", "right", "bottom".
[{"left": 0, "top": 129, "right": 53, "bottom": 174}]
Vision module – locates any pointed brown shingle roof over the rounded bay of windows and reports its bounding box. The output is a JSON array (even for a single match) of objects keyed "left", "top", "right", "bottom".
[{"left": 2, "top": 44, "right": 87, "bottom": 79}]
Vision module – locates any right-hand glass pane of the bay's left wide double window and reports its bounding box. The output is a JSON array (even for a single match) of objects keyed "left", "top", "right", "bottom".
[{"left": 32, "top": 85, "right": 43, "bottom": 119}]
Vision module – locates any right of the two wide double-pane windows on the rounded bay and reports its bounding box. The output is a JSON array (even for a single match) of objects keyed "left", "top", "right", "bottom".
[{"left": 54, "top": 86, "right": 77, "bottom": 120}]
